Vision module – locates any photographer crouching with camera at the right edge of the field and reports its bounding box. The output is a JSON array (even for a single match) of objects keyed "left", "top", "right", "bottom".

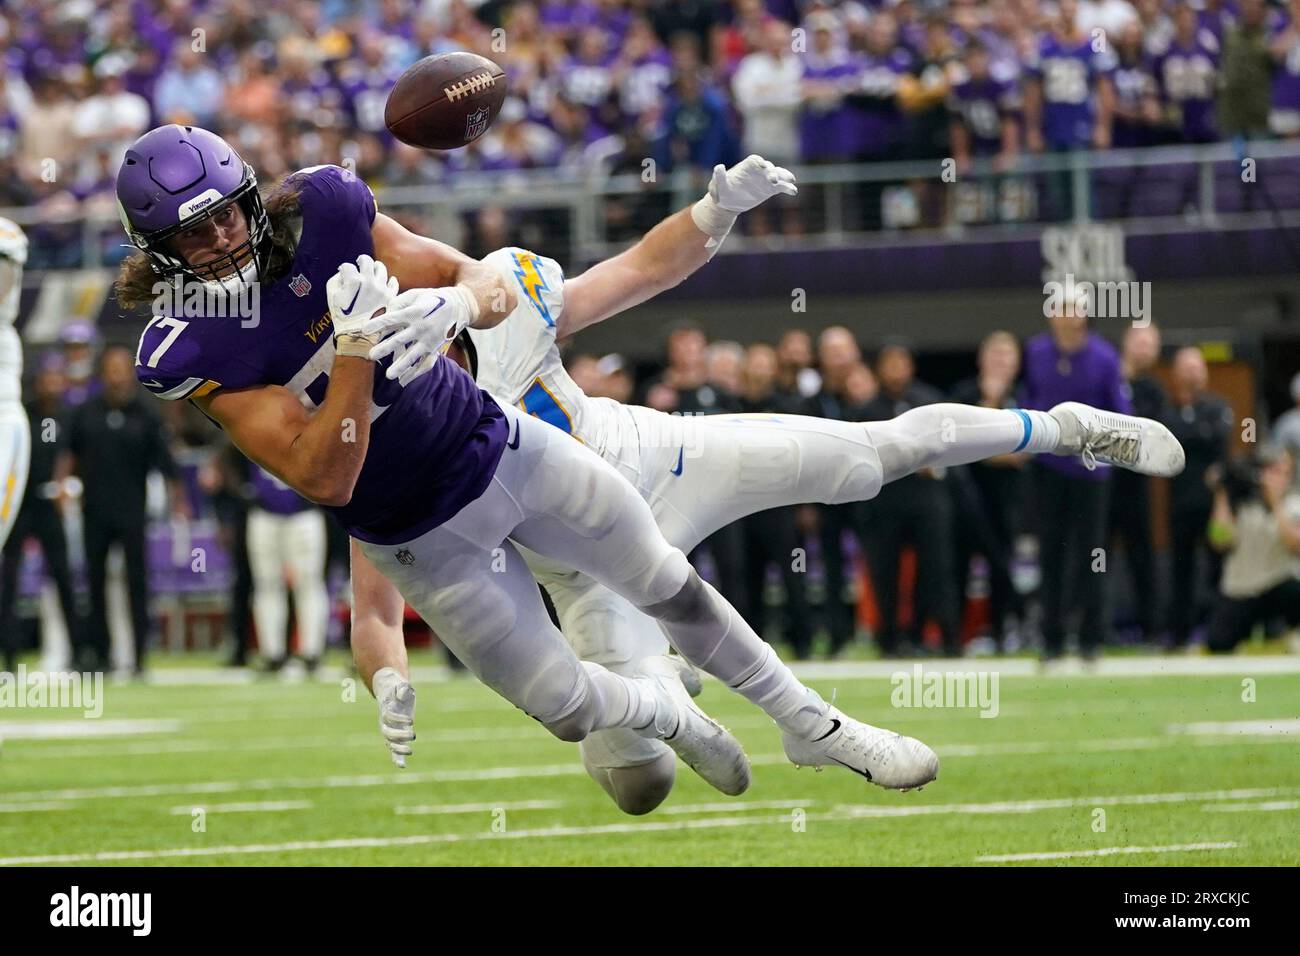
[{"left": 1208, "top": 447, "right": 1300, "bottom": 653}]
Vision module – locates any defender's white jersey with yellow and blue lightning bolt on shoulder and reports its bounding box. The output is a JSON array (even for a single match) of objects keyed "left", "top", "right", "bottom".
[{"left": 469, "top": 248, "right": 637, "bottom": 455}]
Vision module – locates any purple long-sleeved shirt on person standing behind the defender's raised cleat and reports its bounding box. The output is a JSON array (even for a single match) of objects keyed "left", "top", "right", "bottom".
[{"left": 1019, "top": 332, "right": 1132, "bottom": 481}]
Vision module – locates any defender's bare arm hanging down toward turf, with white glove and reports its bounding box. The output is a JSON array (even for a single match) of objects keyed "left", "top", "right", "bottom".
[{"left": 351, "top": 540, "right": 415, "bottom": 767}]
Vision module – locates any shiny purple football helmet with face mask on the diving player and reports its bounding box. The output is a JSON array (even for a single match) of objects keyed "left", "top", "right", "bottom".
[{"left": 117, "top": 125, "right": 270, "bottom": 281}]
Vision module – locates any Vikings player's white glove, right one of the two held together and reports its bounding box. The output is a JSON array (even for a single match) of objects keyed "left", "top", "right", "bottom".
[{"left": 361, "top": 285, "right": 478, "bottom": 386}]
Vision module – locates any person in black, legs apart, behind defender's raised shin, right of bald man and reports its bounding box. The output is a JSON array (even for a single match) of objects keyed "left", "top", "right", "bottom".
[{"left": 859, "top": 345, "right": 961, "bottom": 657}]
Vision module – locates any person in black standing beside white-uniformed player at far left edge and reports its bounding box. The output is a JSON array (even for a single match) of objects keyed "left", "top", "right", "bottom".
[{"left": 0, "top": 355, "right": 87, "bottom": 671}]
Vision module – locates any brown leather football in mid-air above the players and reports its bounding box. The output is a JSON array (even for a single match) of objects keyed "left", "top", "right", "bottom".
[{"left": 384, "top": 52, "right": 506, "bottom": 150}]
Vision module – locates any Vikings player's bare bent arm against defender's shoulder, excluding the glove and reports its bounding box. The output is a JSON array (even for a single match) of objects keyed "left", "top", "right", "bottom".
[{"left": 371, "top": 213, "right": 516, "bottom": 329}]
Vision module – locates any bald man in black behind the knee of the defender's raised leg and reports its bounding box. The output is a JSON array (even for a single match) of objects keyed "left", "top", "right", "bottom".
[{"left": 800, "top": 325, "right": 863, "bottom": 657}]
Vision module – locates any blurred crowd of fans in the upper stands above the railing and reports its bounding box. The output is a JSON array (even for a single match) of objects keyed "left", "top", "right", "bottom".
[{"left": 0, "top": 0, "right": 1300, "bottom": 261}]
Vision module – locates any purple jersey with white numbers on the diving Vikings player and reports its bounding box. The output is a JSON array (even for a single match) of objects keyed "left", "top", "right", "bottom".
[{"left": 135, "top": 166, "right": 507, "bottom": 544}]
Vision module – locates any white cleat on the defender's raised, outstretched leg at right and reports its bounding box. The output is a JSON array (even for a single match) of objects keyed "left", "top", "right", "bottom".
[{"left": 1048, "top": 402, "right": 1187, "bottom": 477}]
